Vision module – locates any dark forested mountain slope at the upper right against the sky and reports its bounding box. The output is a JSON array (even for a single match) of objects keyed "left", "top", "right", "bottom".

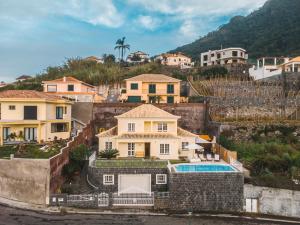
[{"left": 171, "top": 0, "right": 300, "bottom": 59}]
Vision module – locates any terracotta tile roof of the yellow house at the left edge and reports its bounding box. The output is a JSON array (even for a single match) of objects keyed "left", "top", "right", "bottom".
[{"left": 0, "top": 90, "right": 66, "bottom": 101}]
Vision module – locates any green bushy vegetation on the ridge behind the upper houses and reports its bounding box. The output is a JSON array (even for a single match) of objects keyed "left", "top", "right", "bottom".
[{"left": 0, "top": 56, "right": 195, "bottom": 90}]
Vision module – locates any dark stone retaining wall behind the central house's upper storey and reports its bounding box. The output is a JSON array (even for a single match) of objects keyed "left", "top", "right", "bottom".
[{"left": 92, "top": 103, "right": 206, "bottom": 133}]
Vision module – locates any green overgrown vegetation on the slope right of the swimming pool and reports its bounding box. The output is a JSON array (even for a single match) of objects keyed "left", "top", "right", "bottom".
[{"left": 220, "top": 126, "right": 300, "bottom": 189}]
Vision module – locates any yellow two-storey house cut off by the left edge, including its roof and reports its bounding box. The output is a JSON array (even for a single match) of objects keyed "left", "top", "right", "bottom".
[{"left": 0, "top": 90, "right": 72, "bottom": 145}]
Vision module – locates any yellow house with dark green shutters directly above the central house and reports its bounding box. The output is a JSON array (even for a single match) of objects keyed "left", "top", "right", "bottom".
[{"left": 121, "top": 74, "right": 180, "bottom": 103}]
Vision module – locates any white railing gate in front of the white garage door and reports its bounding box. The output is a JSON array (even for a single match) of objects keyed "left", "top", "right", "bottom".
[{"left": 113, "top": 192, "right": 154, "bottom": 206}]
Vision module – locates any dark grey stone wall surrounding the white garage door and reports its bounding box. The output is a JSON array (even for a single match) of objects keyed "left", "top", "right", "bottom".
[{"left": 88, "top": 167, "right": 168, "bottom": 193}]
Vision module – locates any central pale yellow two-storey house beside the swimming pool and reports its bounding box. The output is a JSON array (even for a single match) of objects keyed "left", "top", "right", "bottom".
[{"left": 97, "top": 104, "right": 197, "bottom": 159}]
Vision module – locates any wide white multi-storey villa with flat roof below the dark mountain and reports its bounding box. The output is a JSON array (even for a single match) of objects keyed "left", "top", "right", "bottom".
[{"left": 201, "top": 48, "right": 248, "bottom": 67}]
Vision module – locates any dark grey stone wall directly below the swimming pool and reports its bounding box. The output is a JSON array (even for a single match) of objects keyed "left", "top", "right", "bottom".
[{"left": 168, "top": 173, "right": 244, "bottom": 212}]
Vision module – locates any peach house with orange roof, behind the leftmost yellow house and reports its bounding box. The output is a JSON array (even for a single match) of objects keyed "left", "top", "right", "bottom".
[{"left": 42, "top": 77, "right": 104, "bottom": 102}]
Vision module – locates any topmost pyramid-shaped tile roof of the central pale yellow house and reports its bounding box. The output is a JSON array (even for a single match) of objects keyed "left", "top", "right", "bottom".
[{"left": 116, "top": 104, "right": 180, "bottom": 119}]
